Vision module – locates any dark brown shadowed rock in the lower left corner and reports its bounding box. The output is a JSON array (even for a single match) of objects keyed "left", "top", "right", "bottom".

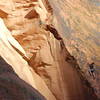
[{"left": 0, "top": 56, "right": 46, "bottom": 100}]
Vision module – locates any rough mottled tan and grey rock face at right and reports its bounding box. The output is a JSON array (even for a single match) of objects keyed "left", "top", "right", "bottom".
[{"left": 48, "top": 0, "right": 100, "bottom": 97}]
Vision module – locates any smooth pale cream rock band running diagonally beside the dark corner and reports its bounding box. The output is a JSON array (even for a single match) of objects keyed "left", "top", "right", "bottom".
[{"left": 0, "top": 19, "right": 56, "bottom": 100}]
